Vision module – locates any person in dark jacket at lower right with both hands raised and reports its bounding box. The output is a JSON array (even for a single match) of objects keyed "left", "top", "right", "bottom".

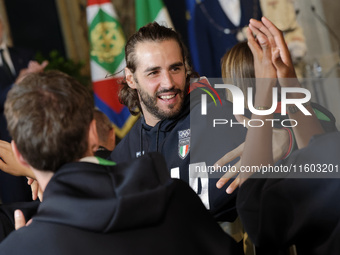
[{"left": 222, "top": 18, "right": 340, "bottom": 255}]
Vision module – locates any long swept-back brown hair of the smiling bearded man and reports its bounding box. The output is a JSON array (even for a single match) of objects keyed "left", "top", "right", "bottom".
[{"left": 118, "top": 22, "right": 192, "bottom": 115}]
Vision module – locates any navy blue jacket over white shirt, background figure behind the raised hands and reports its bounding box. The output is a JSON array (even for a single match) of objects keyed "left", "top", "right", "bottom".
[{"left": 189, "top": 0, "right": 262, "bottom": 78}]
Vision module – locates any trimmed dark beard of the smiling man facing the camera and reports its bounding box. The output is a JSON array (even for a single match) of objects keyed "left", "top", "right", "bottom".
[{"left": 137, "top": 86, "right": 187, "bottom": 120}]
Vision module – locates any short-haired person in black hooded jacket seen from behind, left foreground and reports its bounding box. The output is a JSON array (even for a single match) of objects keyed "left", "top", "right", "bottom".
[{"left": 0, "top": 72, "right": 240, "bottom": 255}]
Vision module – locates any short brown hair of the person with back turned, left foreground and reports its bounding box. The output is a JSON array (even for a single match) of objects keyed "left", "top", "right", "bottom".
[{"left": 5, "top": 71, "right": 94, "bottom": 172}]
